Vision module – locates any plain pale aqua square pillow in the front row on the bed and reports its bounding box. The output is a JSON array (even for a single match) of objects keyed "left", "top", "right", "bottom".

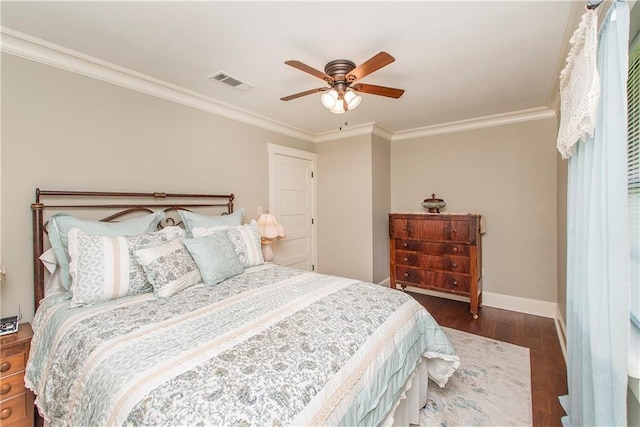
[{"left": 182, "top": 230, "right": 244, "bottom": 286}]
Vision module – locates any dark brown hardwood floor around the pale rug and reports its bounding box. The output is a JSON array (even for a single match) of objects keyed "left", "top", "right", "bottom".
[{"left": 408, "top": 292, "right": 567, "bottom": 426}]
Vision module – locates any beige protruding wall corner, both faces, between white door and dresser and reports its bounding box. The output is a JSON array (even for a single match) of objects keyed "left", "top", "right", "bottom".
[{"left": 316, "top": 130, "right": 391, "bottom": 283}]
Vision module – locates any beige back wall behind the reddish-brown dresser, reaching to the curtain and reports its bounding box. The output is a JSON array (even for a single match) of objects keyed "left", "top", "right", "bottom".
[{"left": 391, "top": 119, "right": 558, "bottom": 302}]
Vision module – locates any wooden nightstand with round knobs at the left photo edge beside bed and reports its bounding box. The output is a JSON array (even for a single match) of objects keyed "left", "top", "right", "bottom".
[{"left": 0, "top": 323, "right": 34, "bottom": 427}]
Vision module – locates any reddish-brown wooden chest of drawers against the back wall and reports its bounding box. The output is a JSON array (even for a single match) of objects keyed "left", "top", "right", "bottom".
[{"left": 389, "top": 213, "right": 482, "bottom": 319}]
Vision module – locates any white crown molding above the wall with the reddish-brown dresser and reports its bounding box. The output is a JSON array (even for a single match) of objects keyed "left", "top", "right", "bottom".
[{"left": 391, "top": 106, "right": 556, "bottom": 142}]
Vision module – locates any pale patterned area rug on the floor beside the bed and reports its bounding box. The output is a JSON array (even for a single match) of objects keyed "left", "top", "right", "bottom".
[{"left": 420, "top": 328, "right": 532, "bottom": 427}]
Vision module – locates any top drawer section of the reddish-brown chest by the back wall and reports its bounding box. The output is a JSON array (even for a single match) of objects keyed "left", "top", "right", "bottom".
[{"left": 389, "top": 218, "right": 470, "bottom": 242}]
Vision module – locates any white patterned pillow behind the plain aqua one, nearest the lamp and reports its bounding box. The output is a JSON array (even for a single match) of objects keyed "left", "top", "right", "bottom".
[{"left": 192, "top": 220, "right": 264, "bottom": 267}]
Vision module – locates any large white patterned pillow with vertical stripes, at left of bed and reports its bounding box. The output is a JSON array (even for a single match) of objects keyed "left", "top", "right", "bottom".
[{"left": 68, "top": 227, "right": 184, "bottom": 307}]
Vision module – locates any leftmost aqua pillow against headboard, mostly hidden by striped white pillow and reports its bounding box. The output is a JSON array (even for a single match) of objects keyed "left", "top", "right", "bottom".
[{"left": 46, "top": 212, "right": 165, "bottom": 290}]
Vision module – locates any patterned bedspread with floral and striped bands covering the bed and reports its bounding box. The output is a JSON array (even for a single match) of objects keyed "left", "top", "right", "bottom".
[{"left": 26, "top": 264, "right": 458, "bottom": 426}]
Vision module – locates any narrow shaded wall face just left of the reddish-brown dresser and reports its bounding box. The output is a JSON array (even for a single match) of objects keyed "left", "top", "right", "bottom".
[{"left": 371, "top": 135, "right": 391, "bottom": 283}]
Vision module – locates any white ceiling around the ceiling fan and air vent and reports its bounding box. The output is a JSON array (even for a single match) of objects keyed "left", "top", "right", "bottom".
[{"left": 1, "top": 0, "right": 586, "bottom": 135}]
